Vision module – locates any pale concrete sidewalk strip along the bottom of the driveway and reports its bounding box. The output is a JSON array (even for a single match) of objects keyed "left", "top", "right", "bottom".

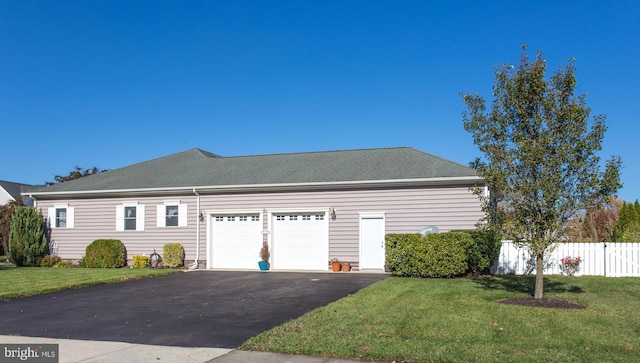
[{"left": 0, "top": 335, "right": 390, "bottom": 363}]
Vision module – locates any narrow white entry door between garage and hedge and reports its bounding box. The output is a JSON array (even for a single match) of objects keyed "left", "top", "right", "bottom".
[{"left": 360, "top": 213, "right": 385, "bottom": 270}]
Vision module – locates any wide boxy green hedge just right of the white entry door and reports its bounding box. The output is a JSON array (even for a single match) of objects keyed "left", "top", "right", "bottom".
[{"left": 386, "top": 232, "right": 473, "bottom": 277}]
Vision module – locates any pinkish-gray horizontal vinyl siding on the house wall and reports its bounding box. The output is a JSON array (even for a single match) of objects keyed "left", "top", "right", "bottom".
[{"left": 38, "top": 185, "right": 482, "bottom": 265}]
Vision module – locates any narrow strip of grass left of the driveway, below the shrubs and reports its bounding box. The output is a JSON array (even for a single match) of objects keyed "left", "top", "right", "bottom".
[{"left": 0, "top": 265, "right": 179, "bottom": 300}]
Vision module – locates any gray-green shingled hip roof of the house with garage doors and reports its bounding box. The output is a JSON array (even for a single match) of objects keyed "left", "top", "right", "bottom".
[{"left": 30, "top": 147, "right": 479, "bottom": 196}]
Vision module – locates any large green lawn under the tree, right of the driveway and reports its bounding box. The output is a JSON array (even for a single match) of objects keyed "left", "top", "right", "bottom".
[{"left": 240, "top": 276, "right": 640, "bottom": 362}]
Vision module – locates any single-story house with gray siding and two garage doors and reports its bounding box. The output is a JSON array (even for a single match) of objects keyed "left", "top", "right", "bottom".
[{"left": 26, "top": 147, "right": 484, "bottom": 270}]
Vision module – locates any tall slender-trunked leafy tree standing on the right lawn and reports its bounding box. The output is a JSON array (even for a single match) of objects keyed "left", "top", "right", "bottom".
[{"left": 463, "top": 46, "right": 621, "bottom": 299}]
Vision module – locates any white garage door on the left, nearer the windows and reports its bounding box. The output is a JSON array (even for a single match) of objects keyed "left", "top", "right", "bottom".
[{"left": 211, "top": 214, "right": 262, "bottom": 270}]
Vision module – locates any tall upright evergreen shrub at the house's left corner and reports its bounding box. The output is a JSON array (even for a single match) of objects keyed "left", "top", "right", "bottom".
[{"left": 9, "top": 206, "right": 49, "bottom": 266}]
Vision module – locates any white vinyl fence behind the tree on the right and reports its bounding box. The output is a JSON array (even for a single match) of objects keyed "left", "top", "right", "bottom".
[{"left": 491, "top": 241, "right": 640, "bottom": 277}]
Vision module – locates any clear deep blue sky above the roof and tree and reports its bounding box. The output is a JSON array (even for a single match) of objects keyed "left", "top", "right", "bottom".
[{"left": 0, "top": 0, "right": 640, "bottom": 201}]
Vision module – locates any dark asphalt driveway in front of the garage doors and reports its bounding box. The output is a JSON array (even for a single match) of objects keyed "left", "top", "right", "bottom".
[{"left": 0, "top": 271, "right": 387, "bottom": 348}]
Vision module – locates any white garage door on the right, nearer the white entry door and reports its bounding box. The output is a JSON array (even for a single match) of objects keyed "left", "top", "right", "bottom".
[{"left": 272, "top": 212, "right": 329, "bottom": 270}]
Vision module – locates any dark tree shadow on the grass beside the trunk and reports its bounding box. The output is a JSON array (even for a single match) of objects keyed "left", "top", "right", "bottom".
[{"left": 473, "top": 275, "right": 585, "bottom": 296}]
